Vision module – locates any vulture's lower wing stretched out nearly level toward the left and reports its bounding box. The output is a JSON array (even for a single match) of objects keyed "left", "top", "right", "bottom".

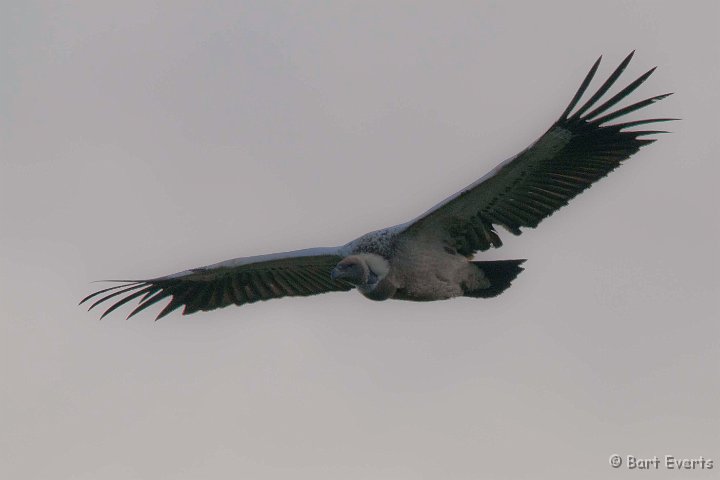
[{"left": 80, "top": 248, "right": 353, "bottom": 319}]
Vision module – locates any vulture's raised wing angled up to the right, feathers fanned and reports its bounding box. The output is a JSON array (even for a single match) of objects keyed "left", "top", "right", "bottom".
[{"left": 400, "top": 52, "right": 675, "bottom": 256}]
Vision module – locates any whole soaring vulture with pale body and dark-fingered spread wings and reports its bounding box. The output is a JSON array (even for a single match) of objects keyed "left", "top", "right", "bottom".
[{"left": 80, "top": 52, "right": 676, "bottom": 319}]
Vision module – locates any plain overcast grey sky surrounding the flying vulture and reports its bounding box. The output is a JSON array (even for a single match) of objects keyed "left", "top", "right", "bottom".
[{"left": 0, "top": 0, "right": 720, "bottom": 480}]
